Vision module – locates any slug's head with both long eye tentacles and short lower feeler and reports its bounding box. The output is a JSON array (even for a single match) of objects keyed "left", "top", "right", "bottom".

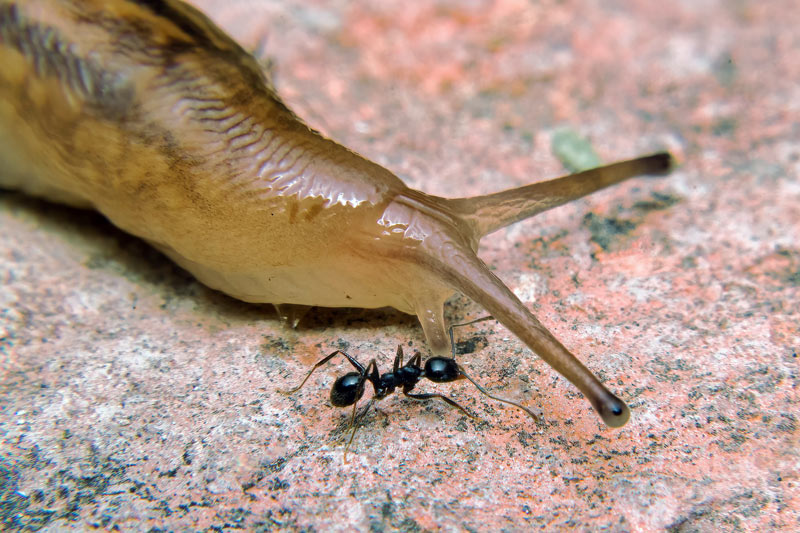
[{"left": 372, "top": 153, "right": 672, "bottom": 428}]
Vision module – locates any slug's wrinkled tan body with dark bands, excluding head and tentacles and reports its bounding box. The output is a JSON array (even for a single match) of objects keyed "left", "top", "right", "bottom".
[{"left": 0, "top": 0, "right": 432, "bottom": 312}]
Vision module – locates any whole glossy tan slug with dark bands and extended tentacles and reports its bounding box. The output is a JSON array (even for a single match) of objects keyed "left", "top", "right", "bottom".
[{"left": 0, "top": 0, "right": 670, "bottom": 427}]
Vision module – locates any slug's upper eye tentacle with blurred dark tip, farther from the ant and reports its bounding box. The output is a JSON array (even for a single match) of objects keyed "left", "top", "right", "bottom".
[{"left": 448, "top": 152, "right": 673, "bottom": 236}]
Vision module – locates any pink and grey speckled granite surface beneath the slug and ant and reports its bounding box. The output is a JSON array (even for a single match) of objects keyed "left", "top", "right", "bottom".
[{"left": 0, "top": 0, "right": 800, "bottom": 531}]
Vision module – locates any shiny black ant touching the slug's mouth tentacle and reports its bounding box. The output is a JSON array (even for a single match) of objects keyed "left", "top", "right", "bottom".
[{"left": 281, "top": 316, "right": 539, "bottom": 460}]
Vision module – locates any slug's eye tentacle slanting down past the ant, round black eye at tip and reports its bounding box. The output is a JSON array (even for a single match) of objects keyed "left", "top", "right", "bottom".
[{"left": 420, "top": 249, "right": 630, "bottom": 427}]
